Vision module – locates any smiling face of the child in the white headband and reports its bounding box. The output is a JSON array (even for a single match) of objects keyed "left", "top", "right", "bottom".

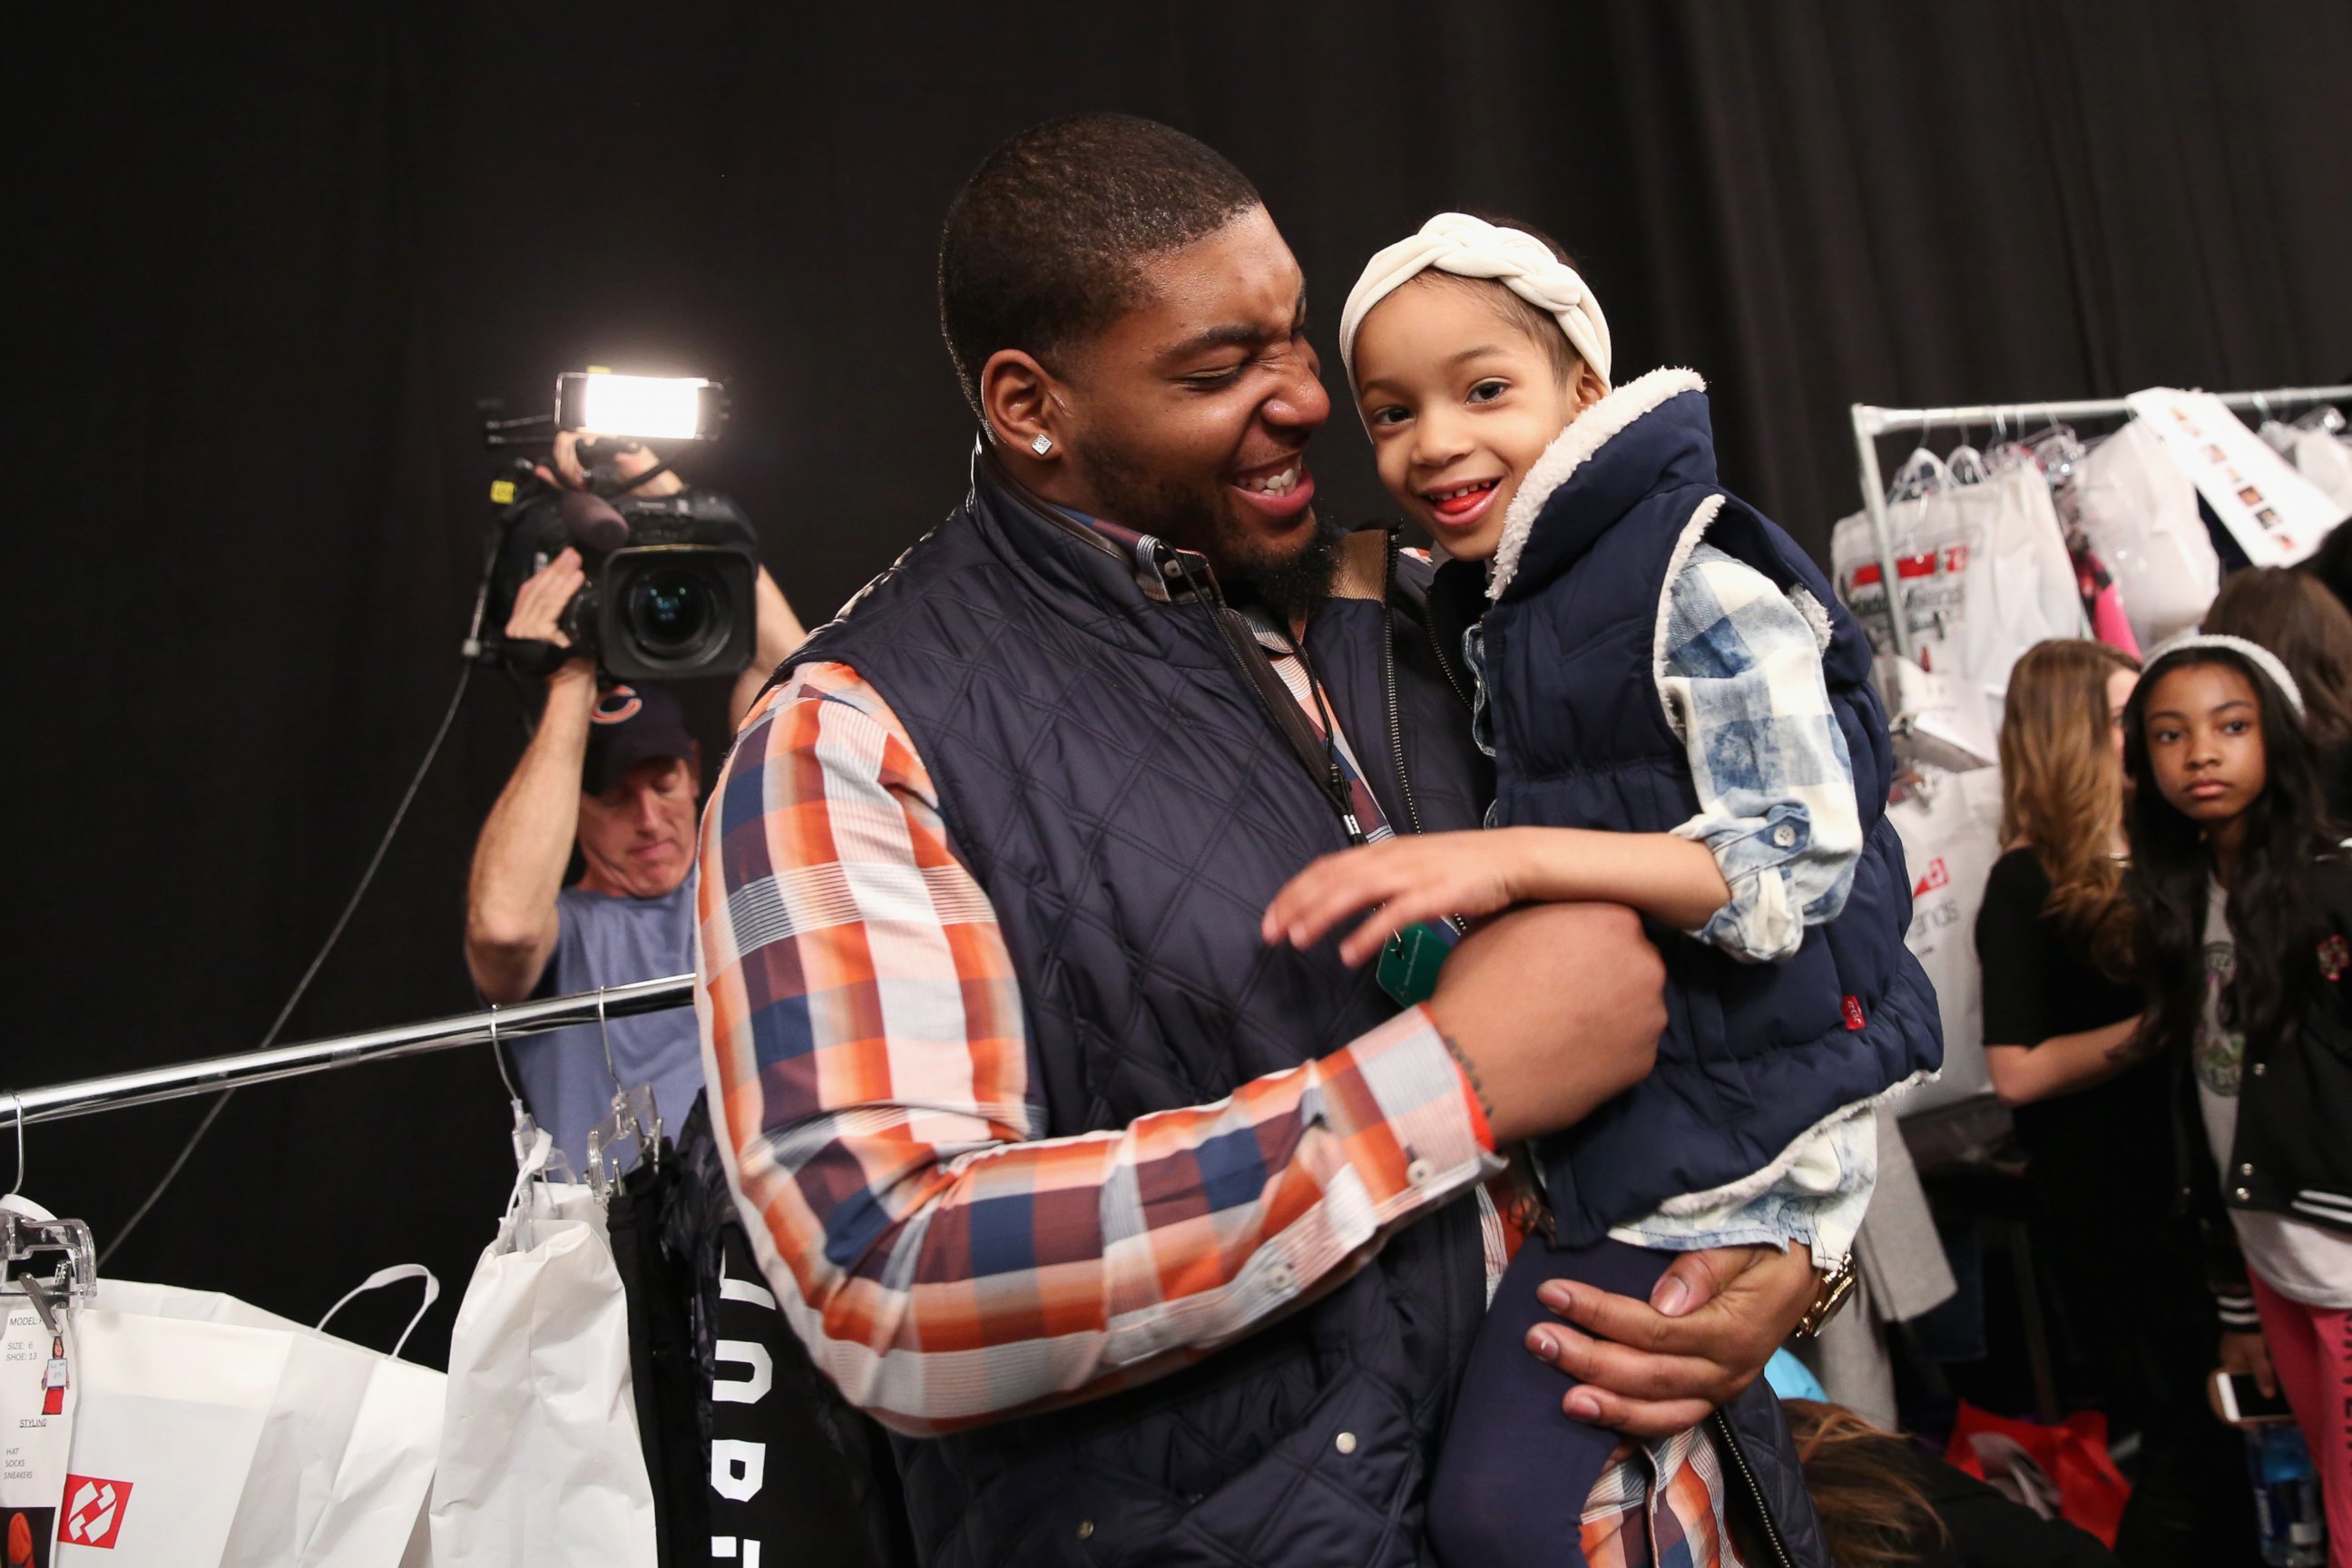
[{"left": 1355, "top": 273, "right": 1604, "bottom": 562}]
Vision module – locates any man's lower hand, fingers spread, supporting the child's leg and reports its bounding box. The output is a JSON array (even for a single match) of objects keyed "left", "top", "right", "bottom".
[{"left": 1526, "top": 1246, "right": 1820, "bottom": 1439}]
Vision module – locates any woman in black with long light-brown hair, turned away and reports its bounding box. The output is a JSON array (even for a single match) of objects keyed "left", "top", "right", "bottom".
[{"left": 1975, "top": 642, "right": 2253, "bottom": 1568}]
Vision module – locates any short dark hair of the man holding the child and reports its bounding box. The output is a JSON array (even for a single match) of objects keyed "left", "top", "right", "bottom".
[{"left": 938, "top": 115, "right": 1260, "bottom": 423}]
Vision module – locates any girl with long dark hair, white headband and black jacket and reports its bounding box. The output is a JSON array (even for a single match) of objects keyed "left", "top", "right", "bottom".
[{"left": 2124, "top": 634, "right": 2352, "bottom": 1552}]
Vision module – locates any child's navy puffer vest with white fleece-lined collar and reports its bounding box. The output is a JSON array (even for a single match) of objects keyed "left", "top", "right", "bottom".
[{"left": 1446, "top": 369, "right": 1943, "bottom": 1243}]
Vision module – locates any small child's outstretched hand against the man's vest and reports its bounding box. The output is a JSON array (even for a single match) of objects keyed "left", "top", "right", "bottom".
[{"left": 1260, "top": 828, "right": 1529, "bottom": 964}]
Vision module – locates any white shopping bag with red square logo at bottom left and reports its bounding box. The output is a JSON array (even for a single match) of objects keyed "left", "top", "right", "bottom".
[{"left": 61, "top": 1265, "right": 445, "bottom": 1568}]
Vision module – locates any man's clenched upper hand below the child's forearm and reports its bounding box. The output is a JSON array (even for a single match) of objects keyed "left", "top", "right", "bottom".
[{"left": 1427, "top": 902, "right": 1665, "bottom": 1147}]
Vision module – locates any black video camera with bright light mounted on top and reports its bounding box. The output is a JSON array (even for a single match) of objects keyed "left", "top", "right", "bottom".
[{"left": 477, "top": 371, "right": 760, "bottom": 680}]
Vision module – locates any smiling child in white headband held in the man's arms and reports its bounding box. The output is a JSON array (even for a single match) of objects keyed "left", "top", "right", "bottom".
[{"left": 1265, "top": 211, "right": 1943, "bottom": 1568}]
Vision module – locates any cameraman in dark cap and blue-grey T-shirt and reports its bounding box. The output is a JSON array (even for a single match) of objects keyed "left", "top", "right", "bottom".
[{"left": 466, "top": 433, "right": 807, "bottom": 1169}]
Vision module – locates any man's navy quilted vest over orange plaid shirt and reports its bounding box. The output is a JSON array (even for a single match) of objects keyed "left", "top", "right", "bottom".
[{"left": 795, "top": 463, "right": 1486, "bottom": 1568}]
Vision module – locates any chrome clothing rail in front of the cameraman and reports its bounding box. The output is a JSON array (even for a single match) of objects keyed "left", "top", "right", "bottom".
[{"left": 0, "top": 975, "right": 694, "bottom": 1129}]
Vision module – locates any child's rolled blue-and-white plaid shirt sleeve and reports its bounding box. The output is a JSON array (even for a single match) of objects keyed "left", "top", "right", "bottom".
[{"left": 1658, "top": 543, "right": 1863, "bottom": 964}]
